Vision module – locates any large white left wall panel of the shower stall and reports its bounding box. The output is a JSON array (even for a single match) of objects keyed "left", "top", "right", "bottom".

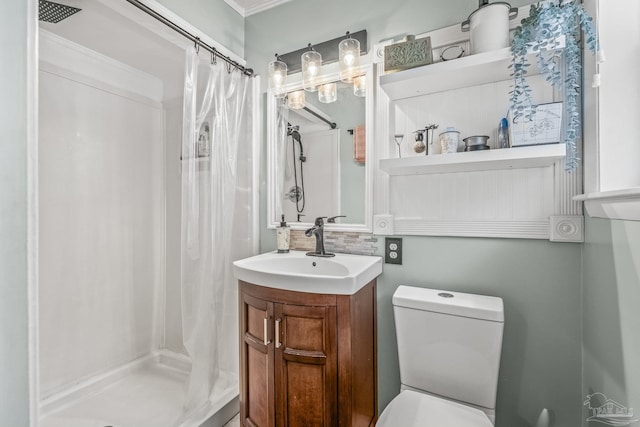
[{"left": 39, "top": 31, "right": 165, "bottom": 397}]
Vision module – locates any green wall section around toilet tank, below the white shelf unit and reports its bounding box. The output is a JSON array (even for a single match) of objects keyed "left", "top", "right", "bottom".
[{"left": 378, "top": 237, "right": 582, "bottom": 427}]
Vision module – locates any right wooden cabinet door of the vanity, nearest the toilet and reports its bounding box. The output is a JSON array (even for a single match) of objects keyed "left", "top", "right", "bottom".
[{"left": 275, "top": 304, "right": 338, "bottom": 427}]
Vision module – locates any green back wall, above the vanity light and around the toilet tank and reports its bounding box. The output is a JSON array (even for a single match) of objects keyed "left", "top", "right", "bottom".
[{"left": 245, "top": 0, "right": 583, "bottom": 427}]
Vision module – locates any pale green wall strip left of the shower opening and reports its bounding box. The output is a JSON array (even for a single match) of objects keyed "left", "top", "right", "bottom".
[{"left": 0, "top": 1, "right": 35, "bottom": 427}]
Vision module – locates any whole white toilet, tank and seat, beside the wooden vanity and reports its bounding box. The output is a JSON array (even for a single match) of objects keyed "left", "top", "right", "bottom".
[{"left": 376, "top": 285, "right": 504, "bottom": 427}]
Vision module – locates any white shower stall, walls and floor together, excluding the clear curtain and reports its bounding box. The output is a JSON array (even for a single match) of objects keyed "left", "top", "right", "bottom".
[{"left": 38, "top": 1, "right": 258, "bottom": 427}]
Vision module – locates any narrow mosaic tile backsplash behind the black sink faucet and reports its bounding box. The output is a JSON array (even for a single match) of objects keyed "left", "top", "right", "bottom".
[{"left": 290, "top": 230, "right": 378, "bottom": 255}]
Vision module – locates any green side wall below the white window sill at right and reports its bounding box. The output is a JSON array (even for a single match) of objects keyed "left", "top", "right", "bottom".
[{"left": 582, "top": 218, "right": 640, "bottom": 426}]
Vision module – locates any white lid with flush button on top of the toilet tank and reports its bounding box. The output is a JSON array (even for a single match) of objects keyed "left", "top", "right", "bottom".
[{"left": 393, "top": 285, "right": 504, "bottom": 322}]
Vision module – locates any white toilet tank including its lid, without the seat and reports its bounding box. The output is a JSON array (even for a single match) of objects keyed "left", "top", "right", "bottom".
[{"left": 393, "top": 286, "right": 504, "bottom": 409}]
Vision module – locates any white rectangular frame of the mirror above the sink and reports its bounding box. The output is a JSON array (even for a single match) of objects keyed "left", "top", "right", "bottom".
[{"left": 266, "top": 64, "right": 375, "bottom": 233}]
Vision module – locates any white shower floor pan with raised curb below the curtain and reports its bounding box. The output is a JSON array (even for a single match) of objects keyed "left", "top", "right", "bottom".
[{"left": 38, "top": 352, "right": 238, "bottom": 427}]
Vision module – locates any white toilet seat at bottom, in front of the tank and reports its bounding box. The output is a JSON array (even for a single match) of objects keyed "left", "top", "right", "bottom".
[{"left": 376, "top": 390, "right": 494, "bottom": 427}]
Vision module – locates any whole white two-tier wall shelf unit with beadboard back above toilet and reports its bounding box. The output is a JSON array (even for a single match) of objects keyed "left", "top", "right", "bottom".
[{"left": 372, "top": 19, "right": 584, "bottom": 242}]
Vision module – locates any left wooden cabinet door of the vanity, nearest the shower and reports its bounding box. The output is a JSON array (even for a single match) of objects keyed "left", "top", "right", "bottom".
[{"left": 240, "top": 292, "right": 275, "bottom": 427}]
